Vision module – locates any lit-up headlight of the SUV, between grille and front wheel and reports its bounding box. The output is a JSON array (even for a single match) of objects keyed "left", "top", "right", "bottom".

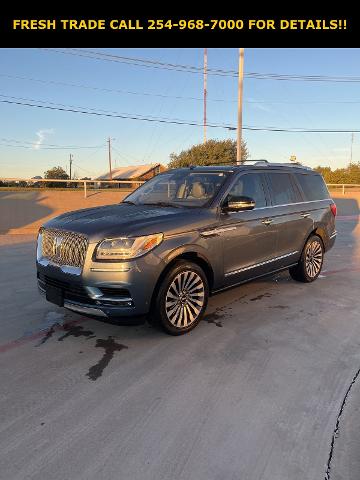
[{"left": 96, "top": 233, "right": 164, "bottom": 261}]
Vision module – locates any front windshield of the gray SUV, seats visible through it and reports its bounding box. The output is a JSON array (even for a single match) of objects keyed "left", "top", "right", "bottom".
[{"left": 124, "top": 170, "right": 227, "bottom": 207}]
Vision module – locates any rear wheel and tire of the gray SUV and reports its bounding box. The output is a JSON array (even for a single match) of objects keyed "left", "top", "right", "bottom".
[{"left": 289, "top": 235, "right": 324, "bottom": 283}]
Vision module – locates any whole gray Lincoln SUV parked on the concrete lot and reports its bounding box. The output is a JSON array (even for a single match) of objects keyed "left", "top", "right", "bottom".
[{"left": 37, "top": 161, "right": 336, "bottom": 335}]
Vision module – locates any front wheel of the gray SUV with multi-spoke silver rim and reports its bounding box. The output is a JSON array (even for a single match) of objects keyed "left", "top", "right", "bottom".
[{"left": 151, "top": 260, "right": 209, "bottom": 335}]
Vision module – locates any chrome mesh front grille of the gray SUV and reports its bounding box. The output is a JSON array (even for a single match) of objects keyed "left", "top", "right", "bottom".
[{"left": 40, "top": 228, "right": 88, "bottom": 267}]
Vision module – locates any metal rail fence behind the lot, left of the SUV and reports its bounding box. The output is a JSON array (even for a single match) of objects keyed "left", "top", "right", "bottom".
[{"left": 0, "top": 178, "right": 145, "bottom": 198}]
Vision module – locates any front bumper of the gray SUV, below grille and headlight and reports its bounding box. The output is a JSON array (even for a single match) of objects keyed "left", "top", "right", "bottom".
[{"left": 36, "top": 248, "right": 164, "bottom": 318}]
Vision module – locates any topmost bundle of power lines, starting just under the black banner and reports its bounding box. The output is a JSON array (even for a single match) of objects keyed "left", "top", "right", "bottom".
[{"left": 41, "top": 48, "right": 360, "bottom": 83}]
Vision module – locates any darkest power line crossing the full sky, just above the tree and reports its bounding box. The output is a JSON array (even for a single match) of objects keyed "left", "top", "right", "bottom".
[{"left": 0, "top": 96, "right": 360, "bottom": 133}]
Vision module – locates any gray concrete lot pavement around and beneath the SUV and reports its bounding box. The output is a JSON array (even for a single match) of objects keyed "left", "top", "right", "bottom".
[{"left": 0, "top": 214, "right": 360, "bottom": 480}]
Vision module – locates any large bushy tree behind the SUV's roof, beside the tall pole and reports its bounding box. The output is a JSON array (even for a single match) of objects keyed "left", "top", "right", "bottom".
[{"left": 169, "top": 139, "right": 249, "bottom": 168}]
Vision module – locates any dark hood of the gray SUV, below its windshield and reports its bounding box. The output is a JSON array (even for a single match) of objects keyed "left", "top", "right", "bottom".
[{"left": 44, "top": 203, "right": 215, "bottom": 242}]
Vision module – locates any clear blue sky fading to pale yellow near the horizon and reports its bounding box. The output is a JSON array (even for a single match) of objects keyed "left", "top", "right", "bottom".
[{"left": 0, "top": 48, "right": 360, "bottom": 178}]
